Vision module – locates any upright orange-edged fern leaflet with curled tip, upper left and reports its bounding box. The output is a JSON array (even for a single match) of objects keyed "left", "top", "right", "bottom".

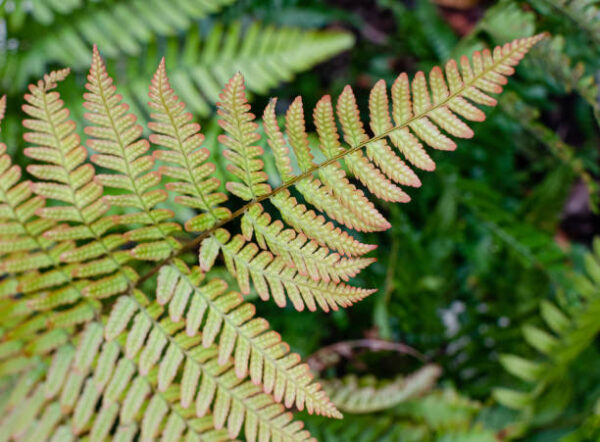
[{"left": 23, "top": 71, "right": 135, "bottom": 296}]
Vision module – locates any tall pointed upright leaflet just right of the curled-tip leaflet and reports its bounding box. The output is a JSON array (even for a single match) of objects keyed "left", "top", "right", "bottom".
[{"left": 84, "top": 46, "right": 179, "bottom": 261}]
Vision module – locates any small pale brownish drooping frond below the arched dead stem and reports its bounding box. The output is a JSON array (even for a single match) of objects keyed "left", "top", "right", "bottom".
[{"left": 324, "top": 365, "right": 441, "bottom": 414}]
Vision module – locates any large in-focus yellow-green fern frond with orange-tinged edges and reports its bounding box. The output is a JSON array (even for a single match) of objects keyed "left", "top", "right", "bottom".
[{"left": 0, "top": 35, "right": 543, "bottom": 441}]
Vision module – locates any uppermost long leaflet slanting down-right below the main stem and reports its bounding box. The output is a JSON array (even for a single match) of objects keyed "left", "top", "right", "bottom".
[{"left": 156, "top": 262, "right": 341, "bottom": 417}]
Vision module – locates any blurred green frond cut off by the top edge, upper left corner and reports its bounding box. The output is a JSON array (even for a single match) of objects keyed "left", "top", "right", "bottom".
[{"left": 3, "top": 0, "right": 235, "bottom": 88}]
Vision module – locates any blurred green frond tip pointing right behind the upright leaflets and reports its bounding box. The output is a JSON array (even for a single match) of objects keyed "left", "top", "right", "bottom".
[{"left": 124, "top": 21, "right": 353, "bottom": 117}]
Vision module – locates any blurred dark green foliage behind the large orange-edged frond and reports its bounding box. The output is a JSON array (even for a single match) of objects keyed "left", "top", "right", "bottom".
[{"left": 0, "top": 0, "right": 600, "bottom": 441}]
